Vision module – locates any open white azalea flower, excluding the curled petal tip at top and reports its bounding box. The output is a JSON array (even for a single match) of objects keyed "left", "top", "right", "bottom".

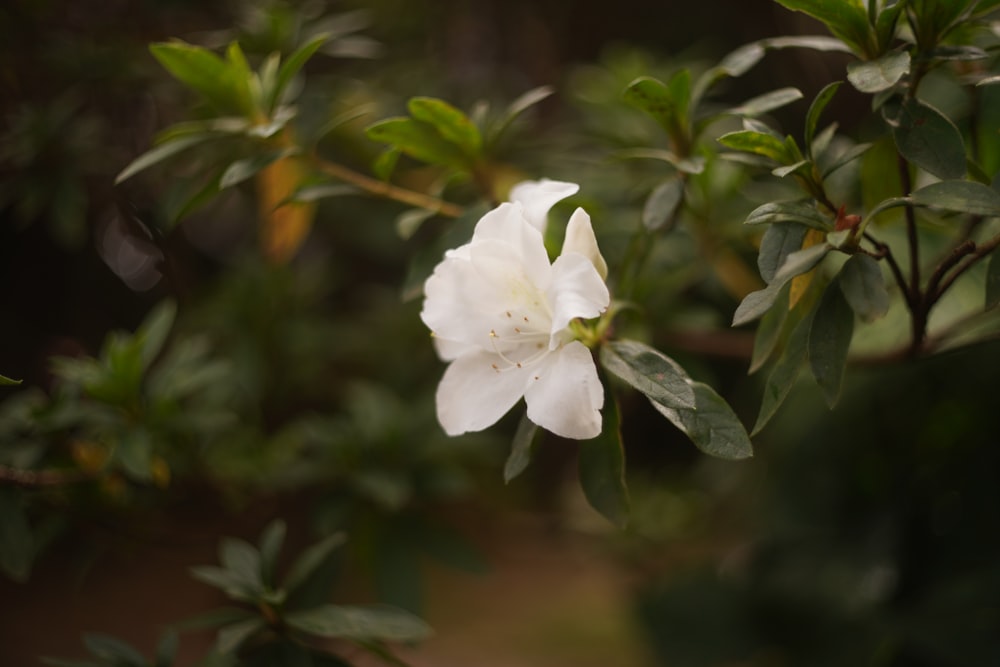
[{"left": 420, "top": 189, "right": 610, "bottom": 439}]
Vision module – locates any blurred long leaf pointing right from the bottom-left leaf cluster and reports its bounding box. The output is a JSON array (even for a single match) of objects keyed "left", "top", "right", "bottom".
[{"left": 285, "top": 604, "right": 432, "bottom": 642}]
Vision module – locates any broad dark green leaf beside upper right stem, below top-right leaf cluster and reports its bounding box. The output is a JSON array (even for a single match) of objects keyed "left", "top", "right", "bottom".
[{"left": 883, "top": 98, "right": 965, "bottom": 180}]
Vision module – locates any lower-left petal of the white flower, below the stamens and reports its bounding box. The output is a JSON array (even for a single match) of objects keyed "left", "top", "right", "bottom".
[{"left": 436, "top": 352, "right": 531, "bottom": 435}]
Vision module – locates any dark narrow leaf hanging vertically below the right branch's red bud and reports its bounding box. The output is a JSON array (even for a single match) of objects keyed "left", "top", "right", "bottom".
[{"left": 809, "top": 280, "right": 854, "bottom": 408}]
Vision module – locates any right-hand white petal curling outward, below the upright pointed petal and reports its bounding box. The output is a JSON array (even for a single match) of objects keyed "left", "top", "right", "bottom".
[{"left": 547, "top": 253, "right": 611, "bottom": 344}]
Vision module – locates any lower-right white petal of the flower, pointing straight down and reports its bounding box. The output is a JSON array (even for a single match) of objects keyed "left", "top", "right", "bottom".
[{"left": 524, "top": 341, "right": 604, "bottom": 440}]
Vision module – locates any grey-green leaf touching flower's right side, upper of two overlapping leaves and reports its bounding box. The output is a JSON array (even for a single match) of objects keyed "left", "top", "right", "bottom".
[{"left": 600, "top": 340, "right": 695, "bottom": 408}]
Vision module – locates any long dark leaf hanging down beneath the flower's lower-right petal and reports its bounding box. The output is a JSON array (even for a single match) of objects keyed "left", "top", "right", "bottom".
[{"left": 578, "top": 388, "right": 629, "bottom": 529}]
